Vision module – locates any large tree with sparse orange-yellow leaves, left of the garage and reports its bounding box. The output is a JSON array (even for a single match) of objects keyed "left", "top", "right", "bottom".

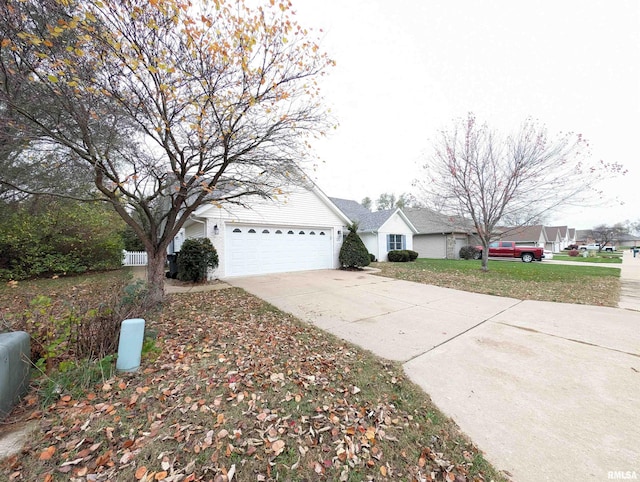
[{"left": 0, "top": 0, "right": 333, "bottom": 301}]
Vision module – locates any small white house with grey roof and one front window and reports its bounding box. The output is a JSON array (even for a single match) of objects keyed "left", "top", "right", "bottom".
[{"left": 330, "top": 198, "right": 418, "bottom": 261}]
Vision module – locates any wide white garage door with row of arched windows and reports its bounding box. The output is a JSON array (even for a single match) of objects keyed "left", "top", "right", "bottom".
[{"left": 225, "top": 226, "right": 333, "bottom": 276}]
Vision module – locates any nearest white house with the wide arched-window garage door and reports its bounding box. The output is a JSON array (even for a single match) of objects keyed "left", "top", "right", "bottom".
[{"left": 176, "top": 183, "right": 350, "bottom": 278}]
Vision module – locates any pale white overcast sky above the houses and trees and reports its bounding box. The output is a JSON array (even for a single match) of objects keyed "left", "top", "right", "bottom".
[{"left": 293, "top": 0, "right": 640, "bottom": 229}]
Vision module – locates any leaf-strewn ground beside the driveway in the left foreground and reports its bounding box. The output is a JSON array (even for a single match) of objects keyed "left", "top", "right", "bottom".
[{"left": 0, "top": 274, "right": 503, "bottom": 482}]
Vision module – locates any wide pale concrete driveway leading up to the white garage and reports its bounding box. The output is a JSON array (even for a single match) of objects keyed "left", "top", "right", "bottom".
[{"left": 230, "top": 271, "right": 640, "bottom": 482}]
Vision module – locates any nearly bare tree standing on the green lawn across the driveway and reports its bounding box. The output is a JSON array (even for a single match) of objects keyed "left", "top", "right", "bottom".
[{"left": 416, "top": 114, "right": 623, "bottom": 270}]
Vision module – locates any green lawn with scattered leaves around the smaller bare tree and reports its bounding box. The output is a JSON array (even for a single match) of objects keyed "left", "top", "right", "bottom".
[{"left": 372, "top": 259, "right": 620, "bottom": 306}]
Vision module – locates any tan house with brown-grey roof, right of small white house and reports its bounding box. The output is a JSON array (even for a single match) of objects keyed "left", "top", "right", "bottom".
[{"left": 405, "top": 208, "right": 478, "bottom": 259}]
